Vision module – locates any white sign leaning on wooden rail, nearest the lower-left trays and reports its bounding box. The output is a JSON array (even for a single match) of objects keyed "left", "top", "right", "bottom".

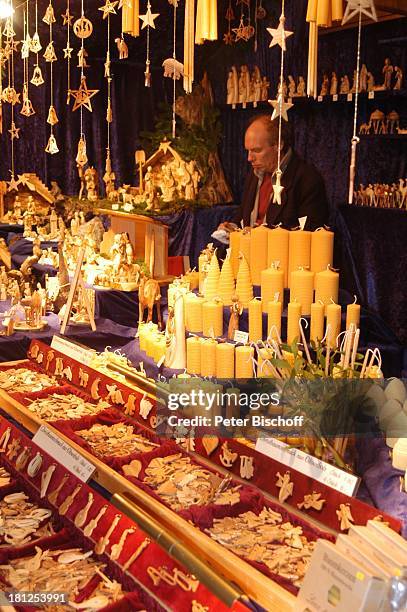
[{"left": 33, "top": 425, "right": 95, "bottom": 482}]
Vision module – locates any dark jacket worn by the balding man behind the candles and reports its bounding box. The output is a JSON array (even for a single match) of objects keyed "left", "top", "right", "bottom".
[{"left": 234, "top": 151, "right": 329, "bottom": 230}]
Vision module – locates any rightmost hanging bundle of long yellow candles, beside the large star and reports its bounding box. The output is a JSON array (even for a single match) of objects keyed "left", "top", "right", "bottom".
[{"left": 306, "top": 0, "right": 343, "bottom": 98}]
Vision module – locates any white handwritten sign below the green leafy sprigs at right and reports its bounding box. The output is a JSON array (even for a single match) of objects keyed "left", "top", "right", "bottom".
[{"left": 256, "top": 438, "right": 360, "bottom": 497}]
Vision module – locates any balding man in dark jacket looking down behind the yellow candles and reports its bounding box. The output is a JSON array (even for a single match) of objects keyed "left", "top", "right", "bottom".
[{"left": 219, "top": 115, "right": 329, "bottom": 230}]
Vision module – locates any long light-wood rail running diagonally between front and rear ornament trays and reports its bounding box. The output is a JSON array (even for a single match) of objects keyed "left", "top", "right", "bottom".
[{"left": 0, "top": 378, "right": 296, "bottom": 612}]
